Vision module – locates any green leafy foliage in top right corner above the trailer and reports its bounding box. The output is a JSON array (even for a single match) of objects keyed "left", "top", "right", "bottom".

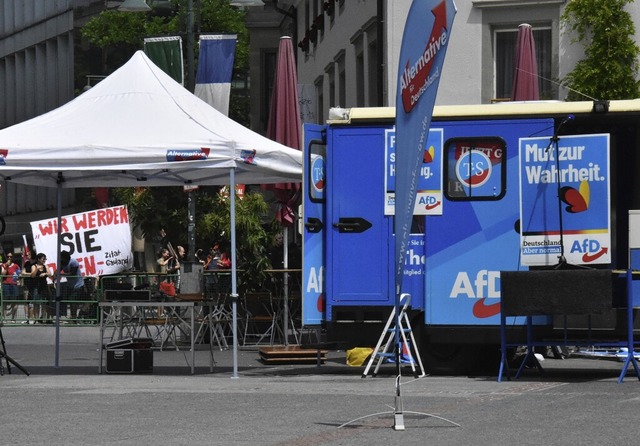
[{"left": 561, "top": 0, "right": 640, "bottom": 100}]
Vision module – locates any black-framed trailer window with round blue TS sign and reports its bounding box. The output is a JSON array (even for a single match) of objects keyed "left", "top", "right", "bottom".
[{"left": 444, "top": 137, "right": 507, "bottom": 200}]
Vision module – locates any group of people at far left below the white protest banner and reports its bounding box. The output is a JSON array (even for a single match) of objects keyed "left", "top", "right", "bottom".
[{"left": 0, "top": 251, "right": 84, "bottom": 324}]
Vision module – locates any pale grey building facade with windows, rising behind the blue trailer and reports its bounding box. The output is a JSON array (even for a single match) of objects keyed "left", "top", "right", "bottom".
[{"left": 249, "top": 0, "right": 640, "bottom": 123}]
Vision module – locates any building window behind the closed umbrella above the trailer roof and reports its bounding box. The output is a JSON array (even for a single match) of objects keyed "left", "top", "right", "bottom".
[{"left": 493, "top": 25, "right": 555, "bottom": 100}]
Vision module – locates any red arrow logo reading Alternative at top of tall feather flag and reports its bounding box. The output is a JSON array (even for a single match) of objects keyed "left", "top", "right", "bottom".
[{"left": 402, "top": 1, "right": 447, "bottom": 113}]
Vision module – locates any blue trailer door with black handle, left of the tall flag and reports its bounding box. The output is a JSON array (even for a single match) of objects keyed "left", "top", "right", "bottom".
[{"left": 327, "top": 126, "right": 393, "bottom": 318}]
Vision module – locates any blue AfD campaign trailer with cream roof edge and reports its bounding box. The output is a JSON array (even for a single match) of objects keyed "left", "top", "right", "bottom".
[{"left": 303, "top": 100, "right": 640, "bottom": 372}]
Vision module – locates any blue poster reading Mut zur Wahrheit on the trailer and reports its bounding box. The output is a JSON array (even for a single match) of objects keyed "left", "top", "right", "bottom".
[{"left": 520, "top": 134, "right": 611, "bottom": 266}]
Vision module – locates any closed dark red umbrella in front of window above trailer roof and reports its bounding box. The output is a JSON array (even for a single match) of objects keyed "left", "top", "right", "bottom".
[{"left": 511, "top": 23, "right": 540, "bottom": 101}]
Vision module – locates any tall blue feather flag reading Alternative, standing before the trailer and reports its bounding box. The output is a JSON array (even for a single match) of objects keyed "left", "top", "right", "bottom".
[{"left": 394, "top": 0, "right": 456, "bottom": 300}]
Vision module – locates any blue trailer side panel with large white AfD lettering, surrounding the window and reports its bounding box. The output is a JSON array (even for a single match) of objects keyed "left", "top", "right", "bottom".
[{"left": 425, "top": 119, "right": 553, "bottom": 326}]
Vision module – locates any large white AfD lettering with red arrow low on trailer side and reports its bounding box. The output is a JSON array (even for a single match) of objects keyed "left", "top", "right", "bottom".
[{"left": 449, "top": 269, "right": 500, "bottom": 319}]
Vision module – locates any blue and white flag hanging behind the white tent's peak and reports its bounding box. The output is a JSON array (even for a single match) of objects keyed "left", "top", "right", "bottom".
[{"left": 194, "top": 34, "right": 237, "bottom": 116}]
